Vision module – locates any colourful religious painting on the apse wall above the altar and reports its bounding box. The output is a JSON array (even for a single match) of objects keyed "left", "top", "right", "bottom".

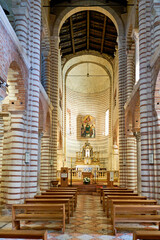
[{"left": 81, "top": 115, "right": 95, "bottom": 138}]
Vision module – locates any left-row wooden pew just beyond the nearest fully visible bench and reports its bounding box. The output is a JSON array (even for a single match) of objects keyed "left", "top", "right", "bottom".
[{"left": 24, "top": 198, "right": 70, "bottom": 223}]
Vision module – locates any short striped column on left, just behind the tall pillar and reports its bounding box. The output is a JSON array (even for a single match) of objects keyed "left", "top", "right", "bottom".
[{"left": 40, "top": 136, "right": 51, "bottom": 190}]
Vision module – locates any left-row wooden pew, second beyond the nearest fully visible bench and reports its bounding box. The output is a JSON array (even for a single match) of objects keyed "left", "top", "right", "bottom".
[{"left": 34, "top": 194, "right": 75, "bottom": 212}]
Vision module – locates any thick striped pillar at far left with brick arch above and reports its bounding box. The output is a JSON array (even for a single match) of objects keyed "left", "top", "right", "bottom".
[{"left": 1, "top": 60, "right": 28, "bottom": 204}]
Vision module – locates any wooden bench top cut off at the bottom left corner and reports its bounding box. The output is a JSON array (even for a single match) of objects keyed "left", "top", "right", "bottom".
[{"left": 0, "top": 230, "right": 47, "bottom": 240}]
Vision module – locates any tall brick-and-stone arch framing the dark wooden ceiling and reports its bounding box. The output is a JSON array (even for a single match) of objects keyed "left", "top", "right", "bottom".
[{"left": 51, "top": 0, "right": 126, "bottom": 182}]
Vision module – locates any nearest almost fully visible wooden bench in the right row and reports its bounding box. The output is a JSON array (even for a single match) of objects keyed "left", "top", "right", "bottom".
[{"left": 112, "top": 205, "right": 160, "bottom": 234}]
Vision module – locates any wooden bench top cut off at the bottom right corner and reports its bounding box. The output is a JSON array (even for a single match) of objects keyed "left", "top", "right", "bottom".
[{"left": 133, "top": 230, "right": 160, "bottom": 240}]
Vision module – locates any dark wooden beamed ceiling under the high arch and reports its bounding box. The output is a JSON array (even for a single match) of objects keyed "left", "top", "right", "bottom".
[{"left": 60, "top": 11, "right": 117, "bottom": 56}]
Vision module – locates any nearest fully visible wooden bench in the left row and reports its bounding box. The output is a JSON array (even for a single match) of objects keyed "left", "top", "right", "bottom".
[{"left": 12, "top": 204, "right": 66, "bottom": 233}]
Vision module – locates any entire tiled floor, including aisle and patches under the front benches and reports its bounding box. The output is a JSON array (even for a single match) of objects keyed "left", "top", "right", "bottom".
[{"left": 0, "top": 195, "right": 156, "bottom": 240}]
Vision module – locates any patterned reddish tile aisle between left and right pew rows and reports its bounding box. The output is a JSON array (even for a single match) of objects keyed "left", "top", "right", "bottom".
[{"left": 66, "top": 195, "right": 112, "bottom": 234}]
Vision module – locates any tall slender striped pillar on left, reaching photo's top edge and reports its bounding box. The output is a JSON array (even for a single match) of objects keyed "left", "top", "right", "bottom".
[{"left": 25, "top": 0, "right": 41, "bottom": 197}]
